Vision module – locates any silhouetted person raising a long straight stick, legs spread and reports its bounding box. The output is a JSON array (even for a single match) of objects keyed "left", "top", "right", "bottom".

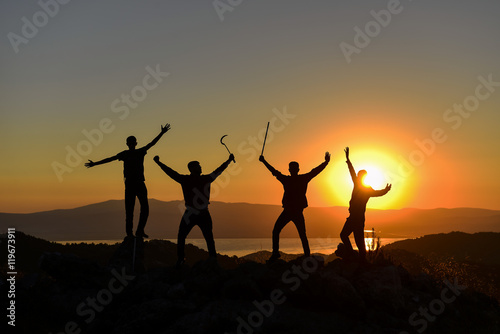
[{"left": 259, "top": 152, "right": 330, "bottom": 262}]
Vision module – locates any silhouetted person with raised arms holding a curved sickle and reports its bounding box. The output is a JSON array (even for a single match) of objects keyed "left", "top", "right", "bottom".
[{"left": 153, "top": 154, "right": 234, "bottom": 267}]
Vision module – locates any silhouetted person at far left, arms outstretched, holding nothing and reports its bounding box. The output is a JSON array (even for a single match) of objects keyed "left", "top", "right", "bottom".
[{"left": 85, "top": 123, "right": 170, "bottom": 238}]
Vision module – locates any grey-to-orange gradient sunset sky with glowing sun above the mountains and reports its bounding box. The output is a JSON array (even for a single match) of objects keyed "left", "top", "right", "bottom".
[{"left": 0, "top": 0, "right": 500, "bottom": 212}]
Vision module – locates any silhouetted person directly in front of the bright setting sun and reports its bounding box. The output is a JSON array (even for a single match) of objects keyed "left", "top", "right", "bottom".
[{"left": 340, "top": 147, "right": 392, "bottom": 262}]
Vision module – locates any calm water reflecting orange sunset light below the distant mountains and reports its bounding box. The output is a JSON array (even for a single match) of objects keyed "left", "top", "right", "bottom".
[{"left": 58, "top": 238, "right": 404, "bottom": 257}]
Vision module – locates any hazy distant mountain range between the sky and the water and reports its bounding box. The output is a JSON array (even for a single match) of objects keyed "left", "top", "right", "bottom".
[{"left": 0, "top": 199, "right": 500, "bottom": 241}]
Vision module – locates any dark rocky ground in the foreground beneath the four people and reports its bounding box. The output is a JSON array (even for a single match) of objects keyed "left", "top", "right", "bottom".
[{"left": 1, "top": 234, "right": 500, "bottom": 334}]
